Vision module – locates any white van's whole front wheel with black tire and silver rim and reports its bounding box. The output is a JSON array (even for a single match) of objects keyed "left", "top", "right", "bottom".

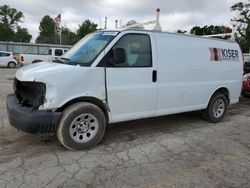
[{"left": 57, "top": 102, "right": 106, "bottom": 150}]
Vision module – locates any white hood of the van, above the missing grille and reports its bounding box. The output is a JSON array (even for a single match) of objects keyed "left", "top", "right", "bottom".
[{"left": 16, "top": 62, "right": 77, "bottom": 81}]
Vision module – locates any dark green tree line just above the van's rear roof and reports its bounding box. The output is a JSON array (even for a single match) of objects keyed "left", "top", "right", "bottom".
[{"left": 190, "top": 25, "right": 232, "bottom": 36}]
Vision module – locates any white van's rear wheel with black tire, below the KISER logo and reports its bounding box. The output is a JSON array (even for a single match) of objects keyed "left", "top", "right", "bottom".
[{"left": 202, "top": 93, "right": 228, "bottom": 123}]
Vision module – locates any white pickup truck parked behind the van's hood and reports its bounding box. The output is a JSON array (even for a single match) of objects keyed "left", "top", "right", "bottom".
[{"left": 17, "top": 48, "right": 68, "bottom": 65}]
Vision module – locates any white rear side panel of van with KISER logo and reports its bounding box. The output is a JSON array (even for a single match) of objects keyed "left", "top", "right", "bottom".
[{"left": 155, "top": 33, "right": 243, "bottom": 115}]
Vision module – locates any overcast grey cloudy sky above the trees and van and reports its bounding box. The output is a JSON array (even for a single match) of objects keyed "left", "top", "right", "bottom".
[{"left": 0, "top": 0, "right": 247, "bottom": 40}]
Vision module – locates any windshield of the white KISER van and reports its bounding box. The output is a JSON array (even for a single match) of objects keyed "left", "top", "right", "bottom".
[{"left": 61, "top": 32, "right": 118, "bottom": 66}]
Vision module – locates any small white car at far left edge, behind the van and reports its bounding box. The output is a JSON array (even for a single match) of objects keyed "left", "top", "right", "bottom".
[{"left": 0, "top": 51, "right": 19, "bottom": 68}]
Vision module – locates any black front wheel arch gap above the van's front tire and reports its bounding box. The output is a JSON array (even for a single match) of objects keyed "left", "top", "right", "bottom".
[{"left": 57, "top": 97, "right": 110, "bottom": 123}]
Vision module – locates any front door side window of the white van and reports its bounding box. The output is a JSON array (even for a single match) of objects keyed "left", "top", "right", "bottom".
[{"left": 101, "top": 34, "right": 152, "bottom": 67}]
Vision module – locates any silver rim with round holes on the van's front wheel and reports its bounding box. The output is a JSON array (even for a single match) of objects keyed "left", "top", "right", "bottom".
[{"left": 69, "top": 114, "right": 99, "bottom": 143}]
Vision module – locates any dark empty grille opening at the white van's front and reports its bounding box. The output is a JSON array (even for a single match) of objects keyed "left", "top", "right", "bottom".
[{"left": 13, "top": 78, "right": 46, "bottom": 109}]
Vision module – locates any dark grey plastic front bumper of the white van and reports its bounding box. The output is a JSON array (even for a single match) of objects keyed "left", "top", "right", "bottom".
[{"left": 6, "top": 94, "right": 61, "bottom": 134}]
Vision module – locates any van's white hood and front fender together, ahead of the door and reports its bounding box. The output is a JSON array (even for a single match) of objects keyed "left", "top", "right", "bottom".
[{"left": 13, "top": 62, "right": 106, "bottom": 110}]
